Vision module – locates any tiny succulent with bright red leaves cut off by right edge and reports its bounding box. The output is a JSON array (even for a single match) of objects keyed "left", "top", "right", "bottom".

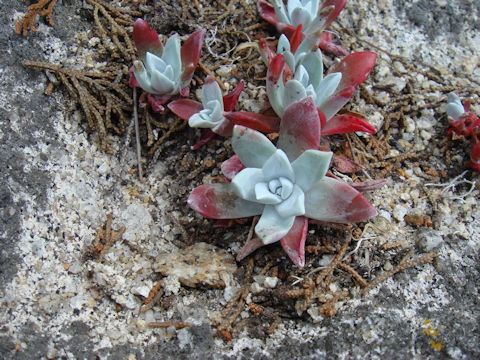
[{"left": 447, "top": 93, "right": 480, "bottom": 172}]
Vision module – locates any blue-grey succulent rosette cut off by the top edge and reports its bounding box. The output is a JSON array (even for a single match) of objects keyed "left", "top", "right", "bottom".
[{"left": 257, "top": 0, "right": 347, "bottom": 55}]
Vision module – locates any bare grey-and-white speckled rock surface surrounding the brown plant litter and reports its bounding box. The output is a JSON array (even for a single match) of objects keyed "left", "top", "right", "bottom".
[{"left": 0, "top": 0, "right": 480, "bottom": 359}]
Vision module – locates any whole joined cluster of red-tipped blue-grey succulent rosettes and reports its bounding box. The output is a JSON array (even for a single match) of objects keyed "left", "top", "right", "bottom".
[{"left": 131, "top": 0, "right": 383, "bottom": 267}]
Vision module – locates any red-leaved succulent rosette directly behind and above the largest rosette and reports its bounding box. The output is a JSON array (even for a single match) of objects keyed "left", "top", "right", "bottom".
[{"left": 267, "top": 50, "right": 377, "bottom": 135}]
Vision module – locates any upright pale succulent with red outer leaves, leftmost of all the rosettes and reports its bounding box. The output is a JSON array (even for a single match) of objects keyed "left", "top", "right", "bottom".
[{"left": 131, "top": 19, "right": 205, "bottom": 110}]
